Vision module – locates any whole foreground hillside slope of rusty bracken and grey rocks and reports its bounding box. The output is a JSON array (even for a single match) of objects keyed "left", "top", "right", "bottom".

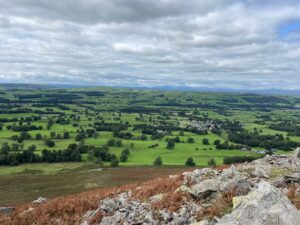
[{"left": 0, "top": 149, "right": 300, "bottom": 225}]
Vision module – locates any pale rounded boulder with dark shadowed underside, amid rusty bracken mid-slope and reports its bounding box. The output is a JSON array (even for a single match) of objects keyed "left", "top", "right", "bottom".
[{"left": 189, "top": 179, "right": 221, "bottom": 199}]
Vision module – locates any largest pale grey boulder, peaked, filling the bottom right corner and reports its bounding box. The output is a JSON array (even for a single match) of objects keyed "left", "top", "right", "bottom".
[{"left": 216, "top": 181, "right": 300, "bottom": 225}]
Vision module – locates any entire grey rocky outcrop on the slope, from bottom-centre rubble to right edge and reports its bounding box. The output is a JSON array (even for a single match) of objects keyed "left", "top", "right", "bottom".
[{"left": 90, "top": 156, "right": 300, "bottom": 225}]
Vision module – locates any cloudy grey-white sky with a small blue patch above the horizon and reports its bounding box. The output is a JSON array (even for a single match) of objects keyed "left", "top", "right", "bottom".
[{"left": 0, "top": 0, "right": 300, "bottom": 90}]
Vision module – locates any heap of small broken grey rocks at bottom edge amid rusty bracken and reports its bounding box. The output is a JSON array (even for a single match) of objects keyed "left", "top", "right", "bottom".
[{"left": 90, "top": 193, "right": 201, "bottom": 225}]
